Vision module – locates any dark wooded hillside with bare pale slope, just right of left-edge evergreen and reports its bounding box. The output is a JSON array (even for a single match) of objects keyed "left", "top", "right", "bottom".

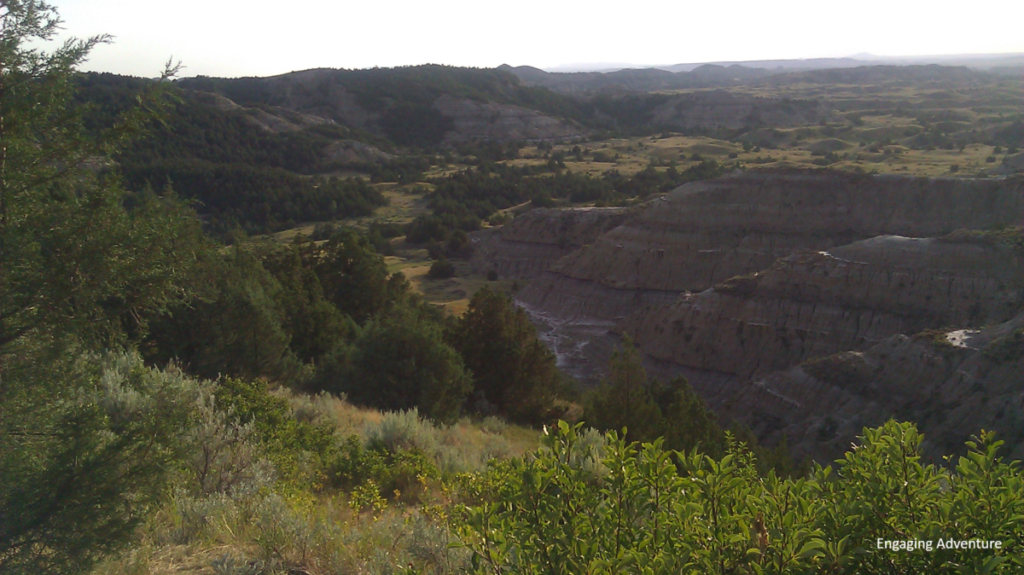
[{"left": 77, "top": 73, "right": 391, "bottom": 233}]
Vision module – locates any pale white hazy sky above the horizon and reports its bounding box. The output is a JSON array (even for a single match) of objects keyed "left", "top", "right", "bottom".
[{"left": 51, "top": 0, "right": 1024, "bottom": 76}]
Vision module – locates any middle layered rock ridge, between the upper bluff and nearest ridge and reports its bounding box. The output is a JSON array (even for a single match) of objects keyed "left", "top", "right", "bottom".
[{"left": 624, "top": 236, "right": 1024, "bottom": 378}]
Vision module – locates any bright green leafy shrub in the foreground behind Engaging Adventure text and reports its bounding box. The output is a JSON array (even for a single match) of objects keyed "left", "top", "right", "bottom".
[{"left": 459, "top": 422, "right": 1024, "bottom": 575}]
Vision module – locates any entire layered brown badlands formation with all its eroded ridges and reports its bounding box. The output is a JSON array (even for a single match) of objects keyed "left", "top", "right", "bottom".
[{"left": 474, "top": 171, "right": 1024, "bottom": 459}]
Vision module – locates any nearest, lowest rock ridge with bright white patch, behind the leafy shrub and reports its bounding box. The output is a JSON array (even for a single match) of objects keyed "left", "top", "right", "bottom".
[{"left": 720, "top": 315, "right": 1024, "bottom": 460}]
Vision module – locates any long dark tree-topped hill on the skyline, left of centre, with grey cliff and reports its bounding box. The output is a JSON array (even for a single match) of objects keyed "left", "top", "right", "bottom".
[{"left": 177, "top": 64, "right": 590, "bottom": 146}]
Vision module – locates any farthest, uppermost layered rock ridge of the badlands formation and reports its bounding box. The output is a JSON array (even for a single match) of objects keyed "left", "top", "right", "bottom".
[{"left": 518, "top": 172, "right": 1024, "bottom": 319}]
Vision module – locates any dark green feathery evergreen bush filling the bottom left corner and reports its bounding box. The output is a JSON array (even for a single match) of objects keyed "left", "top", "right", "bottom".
[{"left": 0, "top": 353, "right": 209, "bottom": 573}]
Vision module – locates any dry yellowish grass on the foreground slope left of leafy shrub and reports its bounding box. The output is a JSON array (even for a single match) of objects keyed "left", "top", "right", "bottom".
[{"left": 95, "top": 390, "right": 540, "bottom": 575}]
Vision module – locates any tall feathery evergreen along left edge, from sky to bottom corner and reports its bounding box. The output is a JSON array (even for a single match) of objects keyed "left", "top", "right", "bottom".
[{"left": 0, "top": 0, "right": 203, "bottom": 574}]
